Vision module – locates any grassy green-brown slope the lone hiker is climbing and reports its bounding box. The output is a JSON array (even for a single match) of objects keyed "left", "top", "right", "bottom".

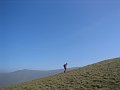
[{"left": 1, "top": 58, "right": 120, "bottom": 90}]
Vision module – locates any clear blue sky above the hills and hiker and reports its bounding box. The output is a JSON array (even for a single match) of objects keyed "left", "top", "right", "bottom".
[{"left": 0, "top": 0, "right": 120, "bottom": 71}]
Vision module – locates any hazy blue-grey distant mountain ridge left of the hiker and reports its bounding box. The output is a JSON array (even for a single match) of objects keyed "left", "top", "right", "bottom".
[{"left": 0, "top": 68, "right": 76, "bottom": 87}]
